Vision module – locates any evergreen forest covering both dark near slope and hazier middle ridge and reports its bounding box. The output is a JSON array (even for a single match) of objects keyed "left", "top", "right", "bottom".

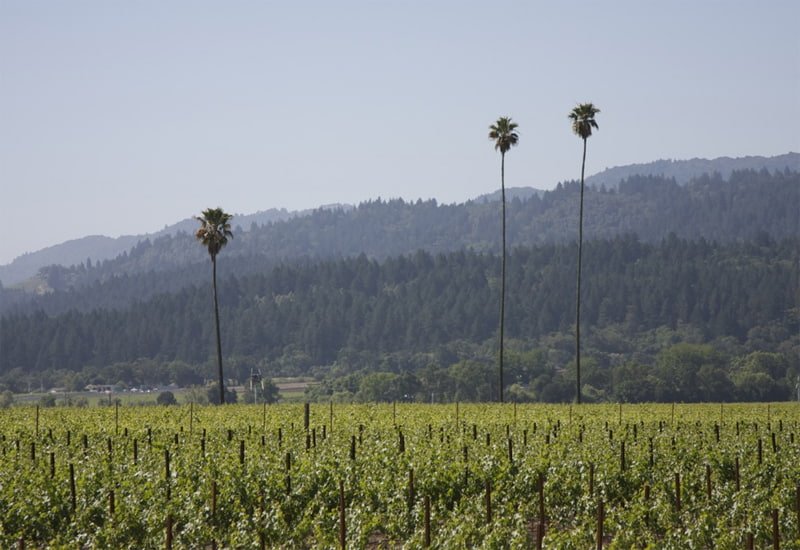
[{"left": 0, "top": 166, "right": 800, "bottom": 402}]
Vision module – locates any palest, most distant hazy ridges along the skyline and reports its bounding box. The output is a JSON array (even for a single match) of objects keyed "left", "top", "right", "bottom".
[{"left": 0, "top": 153, "right": 800, "bottom": 287}]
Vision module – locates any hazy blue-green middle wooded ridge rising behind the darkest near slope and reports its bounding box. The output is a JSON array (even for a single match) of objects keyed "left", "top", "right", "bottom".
[{"left": 0, "top": 170, "right": 800, "bottom": 313}]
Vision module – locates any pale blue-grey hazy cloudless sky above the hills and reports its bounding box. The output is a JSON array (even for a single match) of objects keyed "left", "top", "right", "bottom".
[{"left": 0, "top": 0, "right": 800, "bottom": 264}]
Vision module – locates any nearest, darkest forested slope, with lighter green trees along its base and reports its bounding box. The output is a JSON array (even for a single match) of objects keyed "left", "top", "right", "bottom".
[{"left": 0, "top": 237, "right": 800, "bottom": 401}]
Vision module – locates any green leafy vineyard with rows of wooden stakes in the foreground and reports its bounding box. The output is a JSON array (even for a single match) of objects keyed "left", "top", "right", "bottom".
[{"left": 0, "top": 403, "right": 800, "bottom": 549}]
